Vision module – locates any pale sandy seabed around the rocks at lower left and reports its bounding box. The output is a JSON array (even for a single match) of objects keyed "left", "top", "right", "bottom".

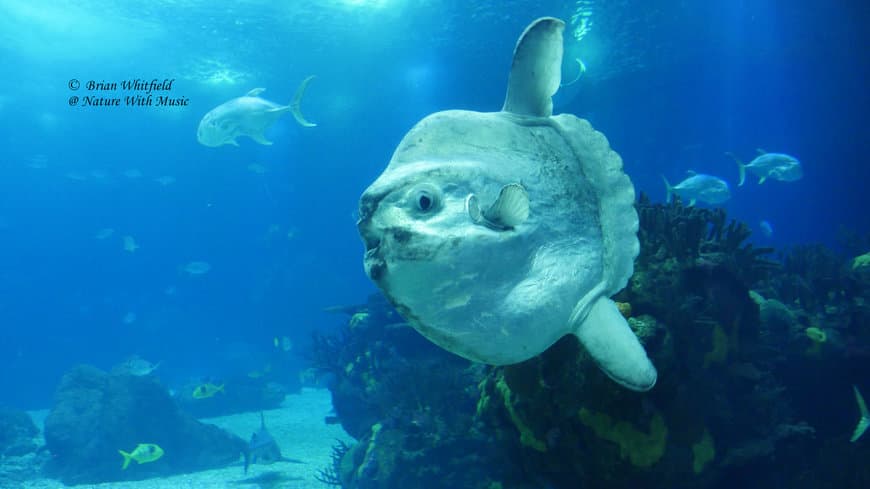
[{"left": 21, "top": 388, "right": 353, "bottom": 489}]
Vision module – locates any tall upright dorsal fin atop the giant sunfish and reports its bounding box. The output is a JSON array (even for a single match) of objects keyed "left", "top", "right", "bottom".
[{"left": 501, "top": 17, "right": 565, "bottom": 117}]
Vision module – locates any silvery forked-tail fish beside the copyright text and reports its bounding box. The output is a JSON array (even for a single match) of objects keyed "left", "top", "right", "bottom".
[{"left": 196, "top": 75, "right": 317, "bottom": 147}]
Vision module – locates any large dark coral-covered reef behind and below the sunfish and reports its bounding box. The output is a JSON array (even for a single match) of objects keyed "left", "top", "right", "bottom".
[{"left": 314, "top": 196, "right": 870, "bottom": 489}]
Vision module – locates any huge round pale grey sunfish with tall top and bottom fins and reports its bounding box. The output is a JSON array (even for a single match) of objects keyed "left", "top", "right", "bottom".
[{"left": 357, "top": 17, "right": 657, "bottom": 391}]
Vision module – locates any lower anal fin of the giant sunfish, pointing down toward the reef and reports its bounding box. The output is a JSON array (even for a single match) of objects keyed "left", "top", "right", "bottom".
[{"left": 574, "top": 297, "right": 658, "bottom": 391}]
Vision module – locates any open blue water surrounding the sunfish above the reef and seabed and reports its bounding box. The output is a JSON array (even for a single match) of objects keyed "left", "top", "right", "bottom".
[{"left": 0, "top": 0, "right": 870, "bottom": 408}]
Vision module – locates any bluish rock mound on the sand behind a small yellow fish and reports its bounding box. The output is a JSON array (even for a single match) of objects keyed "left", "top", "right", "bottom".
[{"left": 45, "top": 366, "right": 246, "bottom": 484}]
